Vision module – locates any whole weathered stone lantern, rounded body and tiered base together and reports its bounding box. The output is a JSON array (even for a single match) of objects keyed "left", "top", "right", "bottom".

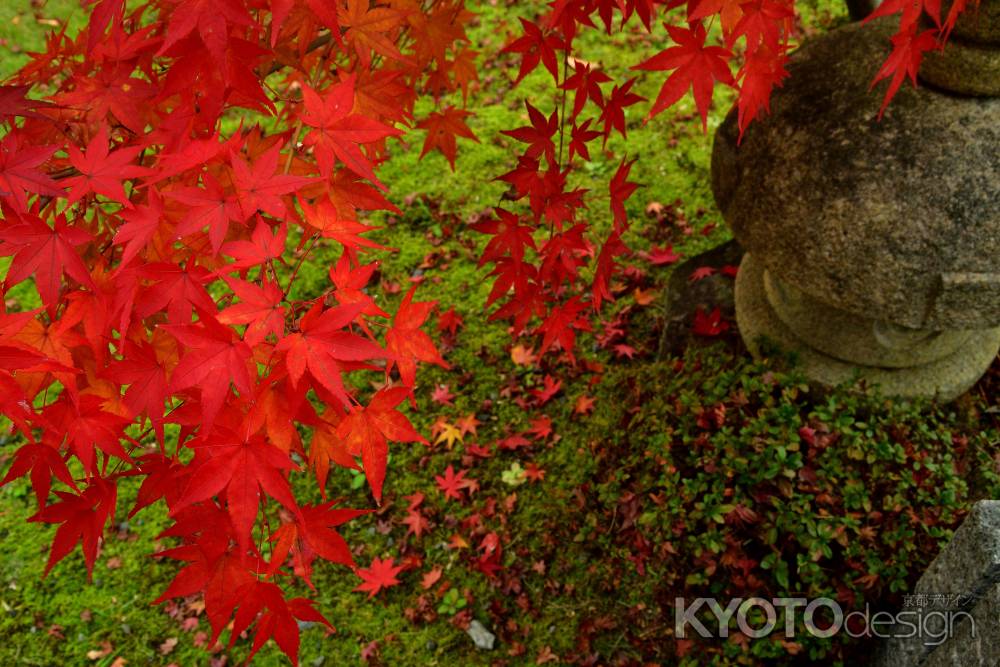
[{"left": 712, "top": 10, "right": 1000, "bottom": 400}]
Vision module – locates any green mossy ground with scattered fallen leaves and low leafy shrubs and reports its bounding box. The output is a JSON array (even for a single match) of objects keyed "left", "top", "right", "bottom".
[{"left": 0, "top": 0, "right": 1000, "bottom": 666}]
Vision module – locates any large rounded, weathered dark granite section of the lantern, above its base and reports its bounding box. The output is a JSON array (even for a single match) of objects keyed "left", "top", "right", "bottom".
[{"left": 712, "top": 19, "right": 1000, "bottom": 332}]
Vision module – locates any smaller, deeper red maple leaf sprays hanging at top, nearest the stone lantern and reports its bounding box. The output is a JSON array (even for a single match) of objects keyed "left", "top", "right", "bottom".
[{"left": 473, "top": 0, "right": 976, "bottom": 361}]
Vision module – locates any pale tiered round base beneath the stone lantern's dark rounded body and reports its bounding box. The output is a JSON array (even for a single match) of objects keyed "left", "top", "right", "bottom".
[{"left": 736, "top": 253, "right": 1000, "bottom": 401}]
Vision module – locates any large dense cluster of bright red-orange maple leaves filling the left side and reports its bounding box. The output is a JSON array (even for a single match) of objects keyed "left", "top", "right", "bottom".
[{"left": 0, "top": 0, "right": 475, "bottom": 664}]
